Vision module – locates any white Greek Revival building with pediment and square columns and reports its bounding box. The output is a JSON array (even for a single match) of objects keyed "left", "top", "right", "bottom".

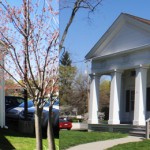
[{"left": 85, "top": 13, "right": 150, "bottom": 125}]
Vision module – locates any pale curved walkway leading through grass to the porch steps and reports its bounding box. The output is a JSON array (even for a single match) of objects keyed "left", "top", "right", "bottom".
[{"left": 67, "top": 136, "right": 144, "bottom": 150}]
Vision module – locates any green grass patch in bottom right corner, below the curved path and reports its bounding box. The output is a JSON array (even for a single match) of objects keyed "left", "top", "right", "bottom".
[{"left": 108, "top": 140, "right": 150, "bottom": 150}]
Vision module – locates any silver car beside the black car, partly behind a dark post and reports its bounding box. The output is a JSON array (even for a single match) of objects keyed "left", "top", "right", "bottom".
[{"left": 6, "top": 100, "right": 34, "bottom": 120}]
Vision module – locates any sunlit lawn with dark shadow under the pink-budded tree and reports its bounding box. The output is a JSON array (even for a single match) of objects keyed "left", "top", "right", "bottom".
[{"left": 0, "top": 129, "right": 59, "bottom": 150}]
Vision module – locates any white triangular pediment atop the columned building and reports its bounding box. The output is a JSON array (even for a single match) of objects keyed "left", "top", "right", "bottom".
[{"left": 86, "top": 15, "right": 150, "bottom": 59}]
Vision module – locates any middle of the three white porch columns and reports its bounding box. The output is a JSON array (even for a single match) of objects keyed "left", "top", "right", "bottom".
[{"left": 108, "top": 70, "right": 122, "bottom": 124}]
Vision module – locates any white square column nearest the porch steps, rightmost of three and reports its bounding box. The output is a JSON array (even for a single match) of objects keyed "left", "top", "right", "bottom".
[{"left": 133, "top": 67, "right": 147, "bottom": 125}]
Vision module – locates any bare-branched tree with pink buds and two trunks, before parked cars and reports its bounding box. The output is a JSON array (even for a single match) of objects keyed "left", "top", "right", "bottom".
[{"left": 0, "top": 0, "right": 59, "bottom": 150}]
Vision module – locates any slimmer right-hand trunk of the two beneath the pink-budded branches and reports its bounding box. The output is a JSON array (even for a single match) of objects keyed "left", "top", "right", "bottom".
[{"left": 47, "top": 106, "right": 56, "bottom": 150}]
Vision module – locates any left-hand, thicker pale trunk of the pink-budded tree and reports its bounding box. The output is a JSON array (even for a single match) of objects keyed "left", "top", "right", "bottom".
[{"left": 35, "top": 106, "right": 43, "bottom": 150}]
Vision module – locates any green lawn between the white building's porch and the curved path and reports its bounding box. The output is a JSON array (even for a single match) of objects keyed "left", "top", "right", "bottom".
[{"left": 59, "top": 130, "right": 127, "bottom": 150}]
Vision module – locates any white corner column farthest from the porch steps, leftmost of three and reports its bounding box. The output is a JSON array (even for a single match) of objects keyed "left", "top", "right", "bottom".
[{"left": 88, "top": 74, "right": 100, "bottom": 124}]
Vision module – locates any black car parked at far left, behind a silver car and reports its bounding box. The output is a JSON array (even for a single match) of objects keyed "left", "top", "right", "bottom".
[{"left": 5, "top": 96, "right": 24, "bottom": 112}]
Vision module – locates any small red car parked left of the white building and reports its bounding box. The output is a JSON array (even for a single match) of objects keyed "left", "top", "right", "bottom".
[{"left": 59, "top": 119, "right": 72, "bottom": 130}]
